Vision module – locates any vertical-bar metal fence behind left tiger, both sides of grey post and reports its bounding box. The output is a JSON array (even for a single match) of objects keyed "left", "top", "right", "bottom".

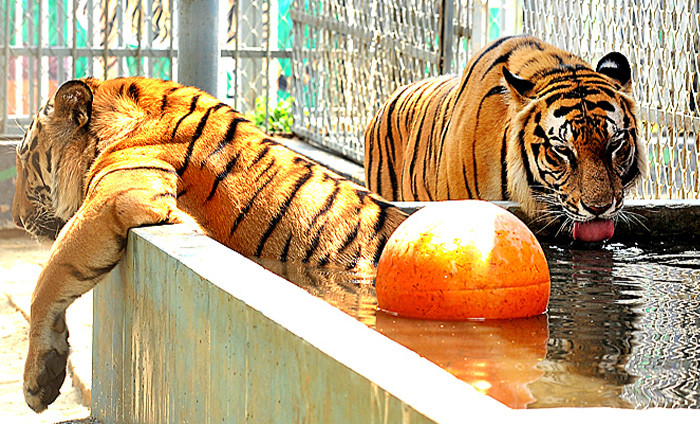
[{"left": 0, "top": 0, "right": 292, "bottom": 138}]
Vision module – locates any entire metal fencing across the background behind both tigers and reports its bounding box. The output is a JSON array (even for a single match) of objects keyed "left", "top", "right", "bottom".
[{"left": 0, "top": 0, "right": 700, "bottom": 199}]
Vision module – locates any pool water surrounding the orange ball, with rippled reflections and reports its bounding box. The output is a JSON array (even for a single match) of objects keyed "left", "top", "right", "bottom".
[{"left": 258, "top": 241, "right": 700, "bottom": 408}]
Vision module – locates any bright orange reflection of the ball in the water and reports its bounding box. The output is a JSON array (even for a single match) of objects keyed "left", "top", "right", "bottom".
[{"left": 376, "top": 312, "right": 547, "bottom": 408}]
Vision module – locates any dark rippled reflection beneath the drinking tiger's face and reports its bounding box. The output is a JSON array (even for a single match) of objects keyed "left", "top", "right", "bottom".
[{"left": 530, "top": 246, "right": 639, "bottom": 407}]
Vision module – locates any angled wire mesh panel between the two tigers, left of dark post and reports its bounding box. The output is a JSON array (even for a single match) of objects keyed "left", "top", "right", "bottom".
[{"left": 292, "top": 0, "right": 441, "bottom": 162}]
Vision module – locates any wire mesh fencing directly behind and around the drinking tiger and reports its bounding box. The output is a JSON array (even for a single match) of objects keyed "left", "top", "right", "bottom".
[{"left": 292, "top": 0, "right": 700, "bottom": 199}]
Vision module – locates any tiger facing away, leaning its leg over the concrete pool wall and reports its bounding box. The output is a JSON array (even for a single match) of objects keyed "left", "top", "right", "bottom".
[{"left": 13, "top": 77, "right": 406, "bottom": 412}]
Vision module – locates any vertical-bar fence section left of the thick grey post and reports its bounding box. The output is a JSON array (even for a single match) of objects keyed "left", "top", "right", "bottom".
[{"left": 0, "top": 0, "right": 176, "bottom": 137}]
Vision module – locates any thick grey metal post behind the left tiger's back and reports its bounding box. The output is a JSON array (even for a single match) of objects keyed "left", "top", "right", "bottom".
[{"left": 177, "top": 0, "right": 221, "bottom": 96}]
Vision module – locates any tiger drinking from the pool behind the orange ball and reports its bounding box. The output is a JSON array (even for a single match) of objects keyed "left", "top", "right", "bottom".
[{"left": 364, "top": 35, "right": 647, "bottom": 242}]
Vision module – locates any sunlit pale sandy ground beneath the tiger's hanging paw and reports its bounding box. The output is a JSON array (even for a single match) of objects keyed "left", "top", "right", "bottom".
[{"left": 0, "top": 231, "right": 97, "bottom": 424}]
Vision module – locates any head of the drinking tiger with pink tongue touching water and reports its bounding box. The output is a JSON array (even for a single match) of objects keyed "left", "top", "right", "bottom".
[{"left": 503, "top": 52, "right": 647, "bottom": 241}]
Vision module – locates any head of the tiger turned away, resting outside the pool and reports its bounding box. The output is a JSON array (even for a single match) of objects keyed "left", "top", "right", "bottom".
[{"left": 12, "top": 81, "right": 92, "bottom": 239}]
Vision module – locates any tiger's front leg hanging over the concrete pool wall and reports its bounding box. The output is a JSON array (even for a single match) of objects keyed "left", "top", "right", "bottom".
[{"left": 23, "top": 164, "right": 194, "bottom": 412}]
